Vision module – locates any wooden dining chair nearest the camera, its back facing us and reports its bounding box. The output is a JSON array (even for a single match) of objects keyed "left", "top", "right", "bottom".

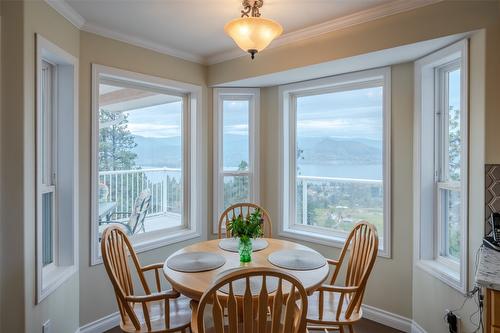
[{"left": 191, "top": 267, "right": 307, "bottom": 333}]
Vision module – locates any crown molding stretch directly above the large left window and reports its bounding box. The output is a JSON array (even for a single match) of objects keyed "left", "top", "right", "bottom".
[{"left": 81, "top": 21, "right": 205, "bottom": 64}]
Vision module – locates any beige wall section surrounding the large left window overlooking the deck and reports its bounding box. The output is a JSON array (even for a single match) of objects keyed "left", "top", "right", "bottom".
[{"left": 80, "top": 32, "right": 211, "bottom": 326}]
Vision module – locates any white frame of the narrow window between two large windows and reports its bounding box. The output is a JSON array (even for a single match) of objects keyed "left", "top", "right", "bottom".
[{"left": 213, "top": 88, "right": 260, "bottom": 234}]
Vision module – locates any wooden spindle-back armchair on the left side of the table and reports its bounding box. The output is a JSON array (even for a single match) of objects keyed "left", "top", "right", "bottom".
[{"left": 101, "top": 226, "right": 191, "bottom": 333}]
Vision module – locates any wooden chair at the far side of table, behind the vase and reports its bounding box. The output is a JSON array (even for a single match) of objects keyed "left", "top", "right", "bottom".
[{"left": 219, "top": 202, "right": 273, "bottom": 239}]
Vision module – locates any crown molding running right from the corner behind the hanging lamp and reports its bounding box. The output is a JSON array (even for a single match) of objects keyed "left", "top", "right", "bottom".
[{"left": 205, "top": 0, "right": 443, "bottom": 65}]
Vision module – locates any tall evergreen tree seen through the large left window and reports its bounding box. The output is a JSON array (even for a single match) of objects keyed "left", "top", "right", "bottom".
[{"left": 99, "top": 109, "right": 137, "bottom": 171}]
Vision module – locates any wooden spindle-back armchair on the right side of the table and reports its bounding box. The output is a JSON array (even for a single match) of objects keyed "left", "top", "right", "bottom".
[{"left": 307, "top": 221, "right": 378, "bottom": 333}]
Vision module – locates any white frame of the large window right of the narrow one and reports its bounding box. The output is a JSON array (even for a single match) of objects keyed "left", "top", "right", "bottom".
[{"left": 278, "top": 67, "right": 391, "bottom": 258}]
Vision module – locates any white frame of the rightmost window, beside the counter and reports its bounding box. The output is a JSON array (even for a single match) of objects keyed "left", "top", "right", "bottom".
[{"left": 413, "top": 39, "right": 469, "bottom": 293}]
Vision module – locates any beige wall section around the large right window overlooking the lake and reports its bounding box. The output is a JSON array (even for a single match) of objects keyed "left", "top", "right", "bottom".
[{"left": 260, "top": 64, "right": 413, "bottom": 318}]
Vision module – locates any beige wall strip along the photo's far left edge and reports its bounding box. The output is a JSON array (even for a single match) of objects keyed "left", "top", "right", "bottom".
[{"left": 0, "top": 1, "right": 25, "bottom": 332}]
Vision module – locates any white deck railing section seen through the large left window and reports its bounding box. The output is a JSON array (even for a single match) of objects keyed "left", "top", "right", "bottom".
[{"left": 99, "top": 168, "right": 182, "bottom": 217}]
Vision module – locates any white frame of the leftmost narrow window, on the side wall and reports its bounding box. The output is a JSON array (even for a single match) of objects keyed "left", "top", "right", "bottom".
[{"left": 35, "top": 34, "right": 79, "bottom": 303}]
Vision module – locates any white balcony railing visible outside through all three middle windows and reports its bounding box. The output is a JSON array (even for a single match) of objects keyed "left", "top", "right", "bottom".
[{"left": 99, "top": 168, "right": 383, "bottom": 225}]
